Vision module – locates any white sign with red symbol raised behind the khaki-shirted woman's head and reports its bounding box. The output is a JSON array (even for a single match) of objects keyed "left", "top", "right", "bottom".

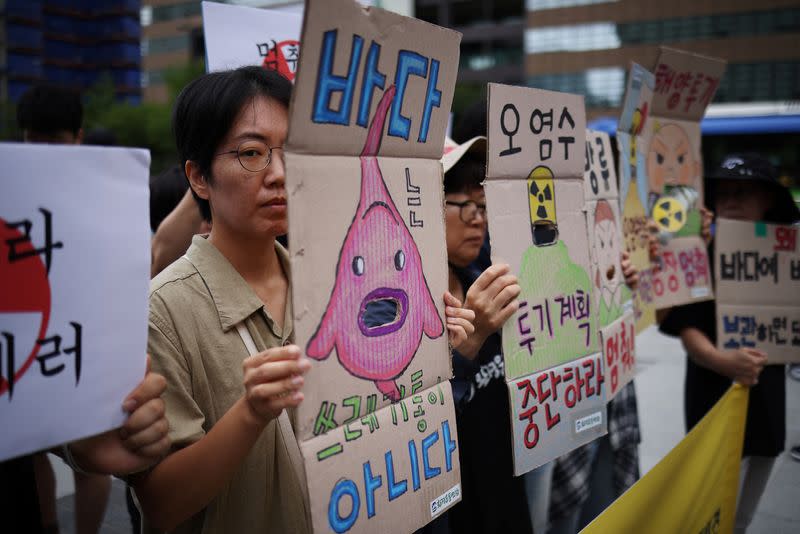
[{"left": 202, "top": 2, "right": 302, "bottom": 81}]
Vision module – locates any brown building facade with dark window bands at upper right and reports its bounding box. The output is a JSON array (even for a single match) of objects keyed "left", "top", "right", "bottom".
[{"left": 525, "top": 0, "right": 800, "bottom": 116}]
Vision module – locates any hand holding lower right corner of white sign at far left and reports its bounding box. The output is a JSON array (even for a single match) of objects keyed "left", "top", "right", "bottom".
[{"left": 69, "top": 359, "right": 171, "bottom": 476}]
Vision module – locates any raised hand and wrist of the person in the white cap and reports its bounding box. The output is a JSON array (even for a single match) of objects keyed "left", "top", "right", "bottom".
[{"left": 458, "top": 264, "right": 522, "bottom": 360}]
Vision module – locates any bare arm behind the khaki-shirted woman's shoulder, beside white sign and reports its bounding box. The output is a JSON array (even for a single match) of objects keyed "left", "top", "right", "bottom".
[{"left": 150, "top": 189, "right": 203, "bottom": 278}]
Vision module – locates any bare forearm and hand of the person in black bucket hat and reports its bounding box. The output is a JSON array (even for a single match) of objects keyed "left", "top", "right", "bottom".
[{"left": 681, "top": 326, "right": 767, "bottom": 386}]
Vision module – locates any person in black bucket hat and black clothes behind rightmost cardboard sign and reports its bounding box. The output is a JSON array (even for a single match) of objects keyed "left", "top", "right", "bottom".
[{"left": 660, "top": 154, "right": 800, "bottom": 532}]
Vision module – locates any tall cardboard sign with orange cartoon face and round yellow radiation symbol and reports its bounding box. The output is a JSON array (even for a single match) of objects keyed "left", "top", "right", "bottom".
[{"left": 644, "top": 47, "right": 725, "bottom": 309}]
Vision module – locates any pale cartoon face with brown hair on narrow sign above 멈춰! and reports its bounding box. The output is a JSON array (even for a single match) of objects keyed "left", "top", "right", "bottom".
[{"left": 592, "top": 200, "right": 622, "bottom": 304}]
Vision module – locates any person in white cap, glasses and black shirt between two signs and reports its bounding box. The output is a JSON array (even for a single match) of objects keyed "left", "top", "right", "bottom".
[{"left": 434, "top": 136, "right": 531, "bottom": 533}]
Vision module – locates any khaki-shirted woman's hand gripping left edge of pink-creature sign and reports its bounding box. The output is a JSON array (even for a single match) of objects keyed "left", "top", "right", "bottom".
[{"left": 242, "top": 345, "right": 311, "bottom": 424}]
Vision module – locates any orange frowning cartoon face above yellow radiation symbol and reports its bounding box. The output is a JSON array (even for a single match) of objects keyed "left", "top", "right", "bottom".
[{"left": 647, "top": 124, "right": 700, "bottom": 195}]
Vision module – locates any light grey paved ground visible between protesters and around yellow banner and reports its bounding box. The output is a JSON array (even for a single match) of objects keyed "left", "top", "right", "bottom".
[{"left": 53, "top": 328, "right": 800, "bottom": 534}]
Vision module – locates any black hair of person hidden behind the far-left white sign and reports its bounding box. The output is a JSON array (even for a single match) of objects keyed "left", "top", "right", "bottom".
[{"left": 17, "top": 84, "right": 83, "bottom": 135}]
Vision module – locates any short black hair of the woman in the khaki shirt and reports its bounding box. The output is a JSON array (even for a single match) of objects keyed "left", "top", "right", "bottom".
[{"left": 172, "top": 66, "right": 292, "bottom": 221}]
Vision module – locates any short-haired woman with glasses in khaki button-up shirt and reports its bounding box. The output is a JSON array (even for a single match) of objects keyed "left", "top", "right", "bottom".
[{"left": 134, "top": 67, "right": 472, "bottom": 533}]
